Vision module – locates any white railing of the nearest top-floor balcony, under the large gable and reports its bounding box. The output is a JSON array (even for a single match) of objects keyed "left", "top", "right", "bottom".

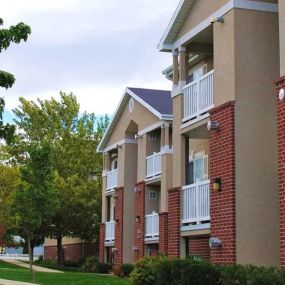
[{"left": 182, "top": 70, "right": 214, "bottom": 122}]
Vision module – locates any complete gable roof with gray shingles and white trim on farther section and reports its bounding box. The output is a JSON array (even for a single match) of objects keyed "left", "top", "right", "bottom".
[{"left": 97, "top": 87, "right": 173, "bottom": 152}]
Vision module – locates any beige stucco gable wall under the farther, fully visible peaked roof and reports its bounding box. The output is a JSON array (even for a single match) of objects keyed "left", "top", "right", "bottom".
[{"left": 106, "top": 97, "right": 158, "bottom": 147}]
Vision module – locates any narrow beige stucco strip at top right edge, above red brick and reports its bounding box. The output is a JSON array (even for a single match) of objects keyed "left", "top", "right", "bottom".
[{"left": 279, "top": 0, "right": 285, "bottom": 76}]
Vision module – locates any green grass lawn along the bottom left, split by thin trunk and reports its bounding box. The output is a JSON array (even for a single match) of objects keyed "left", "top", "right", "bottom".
[{"left": 0, "top": 260, "right": 130, "bottom": 285}]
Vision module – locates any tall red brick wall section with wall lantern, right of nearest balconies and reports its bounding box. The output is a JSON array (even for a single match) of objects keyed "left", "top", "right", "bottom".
[{"left": 210, "top": 102, "right": 236, "bottom": 264}]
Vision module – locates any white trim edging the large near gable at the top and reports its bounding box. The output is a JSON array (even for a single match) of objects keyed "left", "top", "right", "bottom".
[{"left": 159, "top": 0, "right": 278, "bottom": 51}]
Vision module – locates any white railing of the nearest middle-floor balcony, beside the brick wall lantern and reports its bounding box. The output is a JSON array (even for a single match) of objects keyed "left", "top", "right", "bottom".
[{"left": 182, "top": 180, "right": 210, "bottom": 224}]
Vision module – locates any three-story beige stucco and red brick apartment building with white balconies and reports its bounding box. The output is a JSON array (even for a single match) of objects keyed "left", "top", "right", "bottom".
[{"left": 99, "top": 0, "right": 285, "bottom": 270}]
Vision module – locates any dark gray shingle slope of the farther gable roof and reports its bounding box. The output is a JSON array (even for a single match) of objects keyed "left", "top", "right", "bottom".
[{"left": 129, "top": 87, "right": 172, "bottom": 115}]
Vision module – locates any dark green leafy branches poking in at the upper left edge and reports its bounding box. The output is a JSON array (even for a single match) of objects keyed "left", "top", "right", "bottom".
[{"left": 0, "top": 18, "right": 31, "bottom": 142}]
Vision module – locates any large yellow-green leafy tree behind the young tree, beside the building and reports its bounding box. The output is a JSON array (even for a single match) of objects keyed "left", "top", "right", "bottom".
[{"left": 13, "top": 92, "right": 108, "bottom": 265}]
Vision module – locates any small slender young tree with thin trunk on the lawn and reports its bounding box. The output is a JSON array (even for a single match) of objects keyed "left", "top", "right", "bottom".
[{"left": 9, "top": 141, "right": 59, "bottom": 282}]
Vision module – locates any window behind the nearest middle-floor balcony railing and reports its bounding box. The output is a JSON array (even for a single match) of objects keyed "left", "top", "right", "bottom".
[{"left": 186, "top": 153, "right": 208, "bottom": 185}]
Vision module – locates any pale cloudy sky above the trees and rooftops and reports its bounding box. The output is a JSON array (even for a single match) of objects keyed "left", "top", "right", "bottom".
[{"left": 0, "top": 0, "right": 179, "bottom": 121}]
